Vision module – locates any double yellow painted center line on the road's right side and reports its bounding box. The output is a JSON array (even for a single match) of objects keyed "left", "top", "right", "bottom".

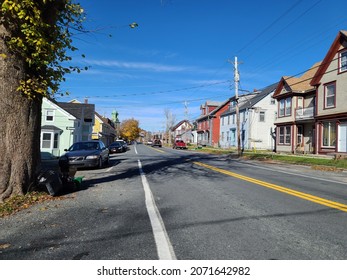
[{"left": 193, "top": 161, "right": 347, "bottom": 212}]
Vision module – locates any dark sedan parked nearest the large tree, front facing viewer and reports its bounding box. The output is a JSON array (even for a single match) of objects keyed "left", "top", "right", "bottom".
[{"left": 59, "top": 141, "right": 110, "bottom": 169}]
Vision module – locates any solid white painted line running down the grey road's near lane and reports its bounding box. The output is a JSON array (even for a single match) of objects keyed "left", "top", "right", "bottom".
[{"left": 137, "top": 159, "right": 176, "bottom": 260}]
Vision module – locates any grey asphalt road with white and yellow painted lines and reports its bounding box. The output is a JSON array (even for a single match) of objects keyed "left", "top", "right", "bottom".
[{"left": 0, "top": 145, "right": 347, "bottom": 260}]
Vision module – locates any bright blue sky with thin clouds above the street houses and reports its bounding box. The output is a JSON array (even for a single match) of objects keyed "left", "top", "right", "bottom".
[{"left": 57, "top": 0, "right": 347, "bottom": 131}]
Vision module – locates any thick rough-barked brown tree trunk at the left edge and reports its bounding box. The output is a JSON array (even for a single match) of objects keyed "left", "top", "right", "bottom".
[{"left": 0, "top": 25, "right": 42, "bottom": 203}]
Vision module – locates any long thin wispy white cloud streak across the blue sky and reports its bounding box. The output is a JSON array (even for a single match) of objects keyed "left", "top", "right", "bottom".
[{"left": 85, "top": 60, "right": 193, "bottom": 72}]
